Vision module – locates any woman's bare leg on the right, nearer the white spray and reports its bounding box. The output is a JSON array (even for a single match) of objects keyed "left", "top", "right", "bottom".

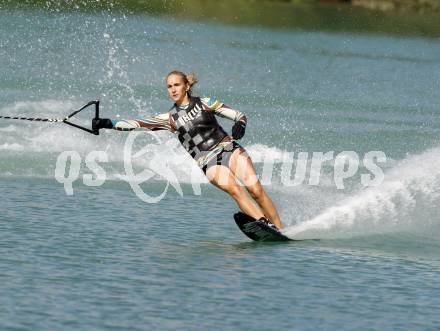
[{"left": 229, "top": 149, "right": 283, "bottom": 229}]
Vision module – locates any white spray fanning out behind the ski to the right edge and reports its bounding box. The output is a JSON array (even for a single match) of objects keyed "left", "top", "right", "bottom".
[{"left": 283, "top": 147, "right": 440, "bottom": 239}]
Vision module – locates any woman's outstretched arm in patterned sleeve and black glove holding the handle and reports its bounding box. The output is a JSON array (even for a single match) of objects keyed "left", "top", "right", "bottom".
[{"left": 92, "top": 113, "right": 175, "bottom": 132}]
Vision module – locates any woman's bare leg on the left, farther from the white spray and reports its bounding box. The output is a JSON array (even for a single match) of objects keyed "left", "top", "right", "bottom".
[{"left": 206, "top": 165, "right": 264, "bottom": 219}]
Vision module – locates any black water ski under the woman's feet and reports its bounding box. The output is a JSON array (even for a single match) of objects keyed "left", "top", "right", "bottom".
[{"left": 234, "top": 212, "right": 292, "bottom": 241}]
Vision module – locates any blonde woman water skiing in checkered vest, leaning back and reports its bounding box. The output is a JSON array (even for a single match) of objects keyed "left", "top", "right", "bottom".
[{"left": 93, "top": 71, "right": 283, "bottom": 229}]
